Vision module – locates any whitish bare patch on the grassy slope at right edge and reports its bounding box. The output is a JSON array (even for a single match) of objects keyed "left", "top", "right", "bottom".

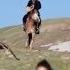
[{"left": 48, "top": 41, "right": 70, "bottom": 52}]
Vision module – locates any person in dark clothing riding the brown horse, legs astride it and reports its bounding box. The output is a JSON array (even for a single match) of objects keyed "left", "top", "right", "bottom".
[{"left": 23, "top": 0, "right": 41, "bottom": 34}]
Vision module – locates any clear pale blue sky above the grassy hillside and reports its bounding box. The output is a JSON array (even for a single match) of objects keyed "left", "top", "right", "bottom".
[{"left": 0, "top": 0, "right": 70, "bottom": 28}]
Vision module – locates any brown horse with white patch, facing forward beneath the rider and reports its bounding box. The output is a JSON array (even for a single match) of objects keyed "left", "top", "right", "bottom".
[{"left": 26, "top": 10, "right": 39, "bottom": 49}]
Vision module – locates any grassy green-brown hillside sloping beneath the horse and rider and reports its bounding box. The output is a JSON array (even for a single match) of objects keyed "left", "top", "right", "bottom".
[{"left": 0, "top": 19, "right": 70, "bottom": 70}]
